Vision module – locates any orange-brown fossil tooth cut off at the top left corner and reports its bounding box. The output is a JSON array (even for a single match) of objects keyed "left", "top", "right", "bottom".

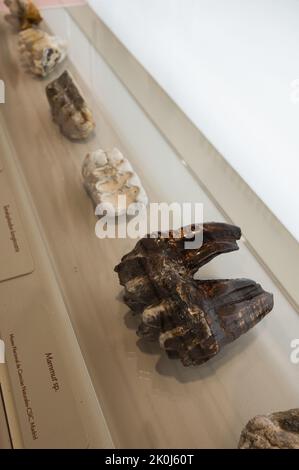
[{"left": 4, "top": 0, "right": 43, "bottom": 30}]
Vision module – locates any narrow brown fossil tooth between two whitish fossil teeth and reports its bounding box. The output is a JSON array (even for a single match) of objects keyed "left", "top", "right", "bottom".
[{"left": 46, "top": 71, "right": 95, "bottom": 140}]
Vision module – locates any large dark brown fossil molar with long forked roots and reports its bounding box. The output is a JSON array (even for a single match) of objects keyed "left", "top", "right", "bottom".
[{"left": 115, "top": 222, "right": 273, "bottom": 366}]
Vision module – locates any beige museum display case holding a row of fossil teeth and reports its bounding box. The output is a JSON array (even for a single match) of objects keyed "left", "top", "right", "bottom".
[{"left": 0, "top": 0, "right": 299, "bottom": 449}]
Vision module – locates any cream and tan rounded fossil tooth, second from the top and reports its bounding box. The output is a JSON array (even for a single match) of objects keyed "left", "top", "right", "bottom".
[{"left": 19, "top": 28, "right": 67, "bottom": 77}]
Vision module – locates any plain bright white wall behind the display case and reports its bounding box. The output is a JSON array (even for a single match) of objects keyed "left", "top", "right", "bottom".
[{"left": 89, "top": 0, "right": 299, "bottom": 240}]
